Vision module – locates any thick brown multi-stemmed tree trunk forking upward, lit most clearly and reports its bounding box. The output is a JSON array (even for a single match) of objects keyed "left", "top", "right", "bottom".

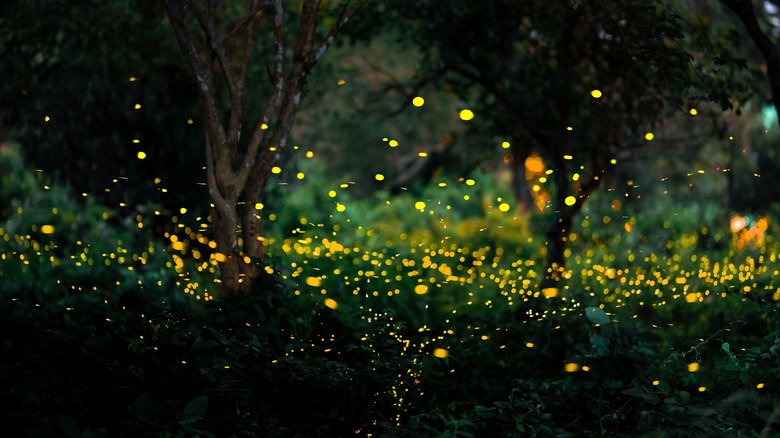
[{"left": 165, "top": 0, "right": 367, "bottom": 294}]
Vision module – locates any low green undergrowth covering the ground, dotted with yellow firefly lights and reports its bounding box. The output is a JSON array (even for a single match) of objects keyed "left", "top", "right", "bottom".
[{"left": 0, "top": 146, "right": 780, "bottom": 437}]
